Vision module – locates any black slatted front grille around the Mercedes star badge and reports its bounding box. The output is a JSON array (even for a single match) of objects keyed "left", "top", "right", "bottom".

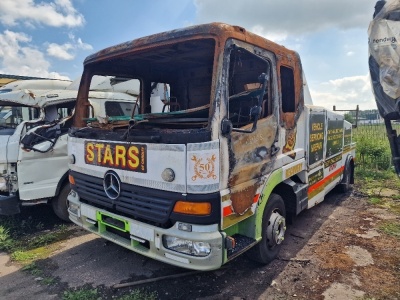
[{"left": 71, "top": 171, "right": 182, "bottom": 225}]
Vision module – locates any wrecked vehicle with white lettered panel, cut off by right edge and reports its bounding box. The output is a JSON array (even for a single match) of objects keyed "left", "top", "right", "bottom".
[{"left": 368, "top": 0, "right": 400, "bottom": 176}]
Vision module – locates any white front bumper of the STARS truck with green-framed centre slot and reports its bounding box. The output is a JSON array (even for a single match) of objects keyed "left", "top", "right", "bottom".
[{"left": 68, "top": 191, "right": 225, "bottom": 271}]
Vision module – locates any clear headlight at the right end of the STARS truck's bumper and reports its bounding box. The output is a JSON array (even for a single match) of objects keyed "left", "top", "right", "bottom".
[{"left": 163, "top": 235, "right": 211, "bottom": 257}]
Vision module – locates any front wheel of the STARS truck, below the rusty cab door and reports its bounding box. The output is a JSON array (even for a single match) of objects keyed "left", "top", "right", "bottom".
[{"left": 248, "top": 194, "right": 286, "bottom": 264}]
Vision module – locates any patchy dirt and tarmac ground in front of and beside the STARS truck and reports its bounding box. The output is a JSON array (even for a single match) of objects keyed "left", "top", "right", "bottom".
[{"left": 0, "top": 187, "right": 400, "bottom": 300}]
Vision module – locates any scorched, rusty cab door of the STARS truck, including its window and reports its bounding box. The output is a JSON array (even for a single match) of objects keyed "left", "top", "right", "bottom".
[{"left": 221, "top": 41, "right": 279, "bottom": 228}]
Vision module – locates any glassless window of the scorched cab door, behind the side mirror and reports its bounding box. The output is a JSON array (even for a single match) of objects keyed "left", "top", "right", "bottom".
[{"left": 228, "top": 48, "right": 272, "bottom": 127}]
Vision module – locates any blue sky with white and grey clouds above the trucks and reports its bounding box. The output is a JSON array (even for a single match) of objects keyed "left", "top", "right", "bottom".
[{"left": 0, "top": 0, "right": 376, "bottom": 109}]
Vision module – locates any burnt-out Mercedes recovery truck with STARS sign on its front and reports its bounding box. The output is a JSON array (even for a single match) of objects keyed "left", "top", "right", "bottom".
[{"left": 68, "top": 23, "right": 355, "bottom": 270}]
